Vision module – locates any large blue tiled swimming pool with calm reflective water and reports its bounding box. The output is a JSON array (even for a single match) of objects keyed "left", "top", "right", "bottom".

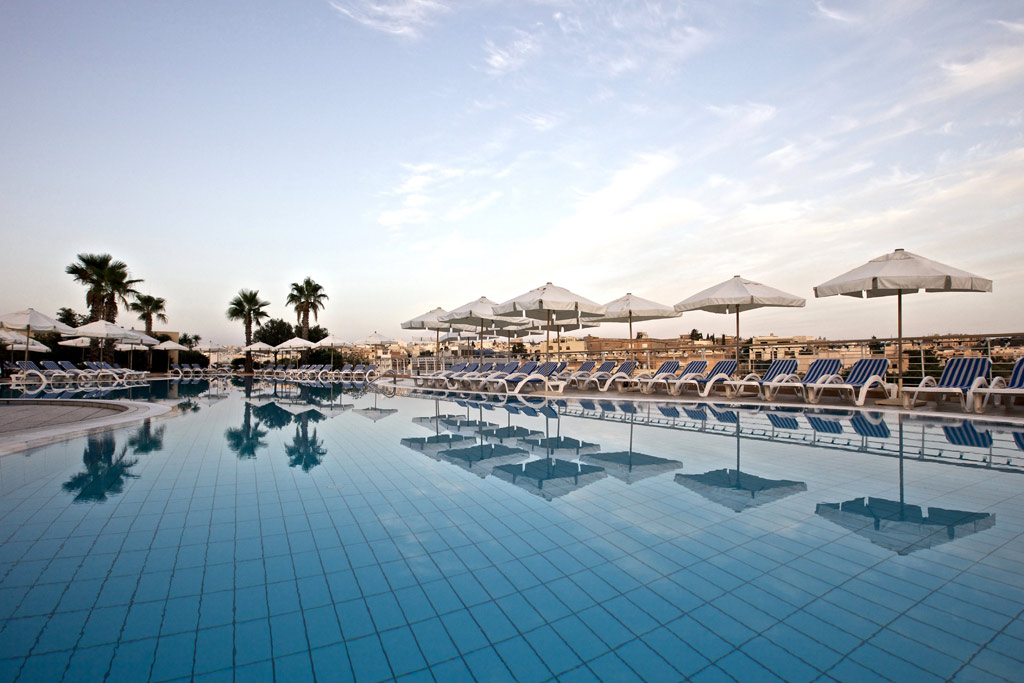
[{"left": 0, "top": 382, "right": 1024, "bottom": 681}]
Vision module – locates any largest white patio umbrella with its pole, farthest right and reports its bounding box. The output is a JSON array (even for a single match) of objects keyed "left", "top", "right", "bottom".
[{"left": 814, "top": 249, "right": 992, "bottom": 393}]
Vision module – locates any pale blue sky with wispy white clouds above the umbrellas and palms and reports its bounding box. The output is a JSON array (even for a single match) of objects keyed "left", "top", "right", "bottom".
[{"left": 0, "top": 0, "right": 1024, "bottom": 344}]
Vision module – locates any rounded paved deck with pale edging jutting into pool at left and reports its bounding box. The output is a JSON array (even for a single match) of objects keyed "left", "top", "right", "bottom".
[{"left": 0, "top": 398, "right": 171, "bottom": 456}]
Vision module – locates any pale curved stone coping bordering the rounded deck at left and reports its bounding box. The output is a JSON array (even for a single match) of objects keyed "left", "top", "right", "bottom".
[{"left": 0, "top": 398, "right": 173, "bottom": 457}]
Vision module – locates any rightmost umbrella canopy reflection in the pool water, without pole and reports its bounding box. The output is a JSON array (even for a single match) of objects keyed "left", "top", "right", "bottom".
[{"left": 815, "top": 498, "right": 995, "bottom": 555}]
